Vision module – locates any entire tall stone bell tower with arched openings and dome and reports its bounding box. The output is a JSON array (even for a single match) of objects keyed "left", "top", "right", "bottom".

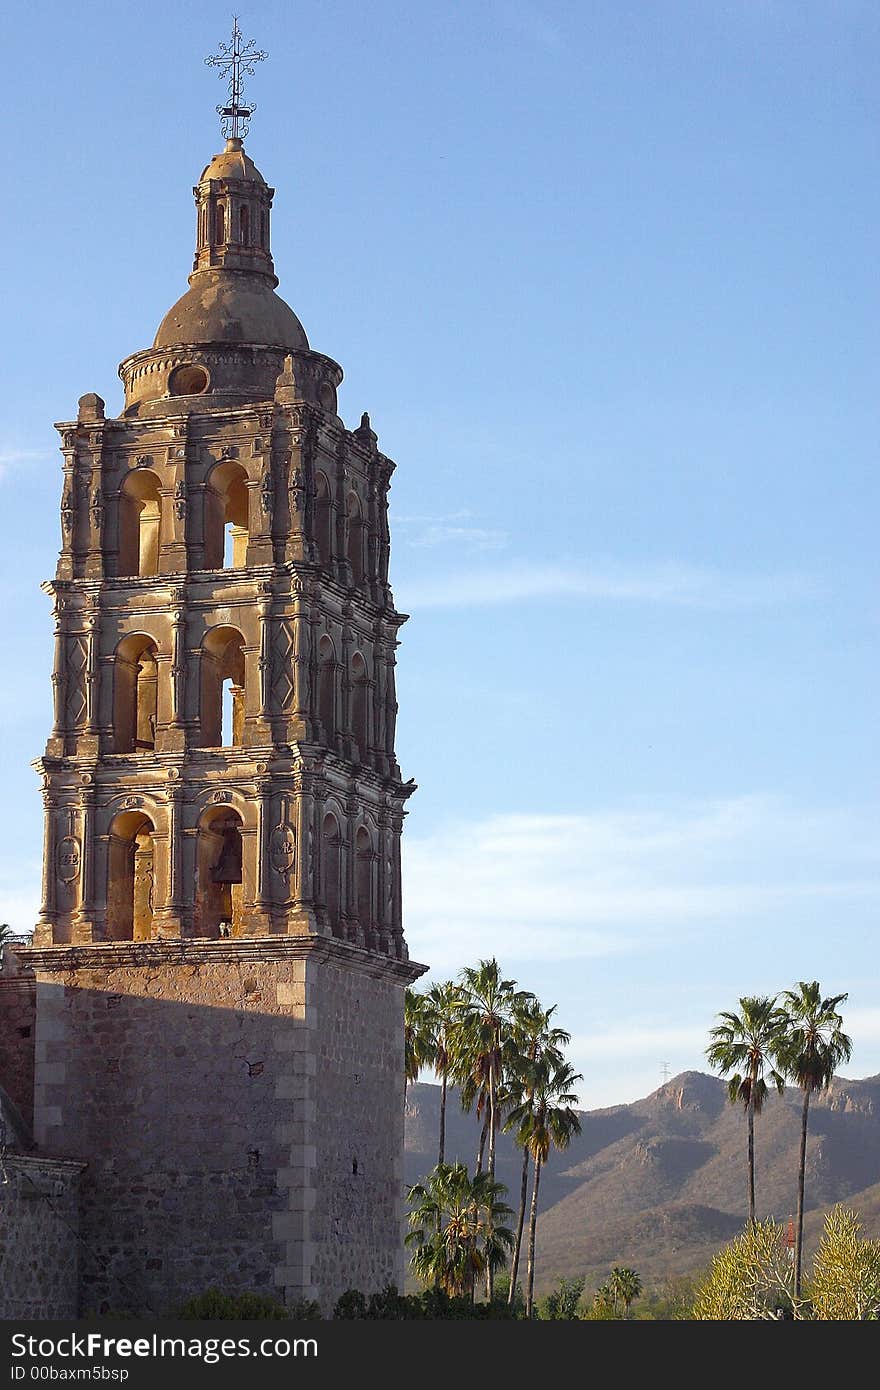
[{"left": 19, "top": 46, "right": 424, "bottom": 1314}]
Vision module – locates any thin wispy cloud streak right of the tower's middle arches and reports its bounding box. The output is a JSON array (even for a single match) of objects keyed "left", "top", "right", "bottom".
[{"left": 399, "top": 563, "right": 815, "bottom": 610}]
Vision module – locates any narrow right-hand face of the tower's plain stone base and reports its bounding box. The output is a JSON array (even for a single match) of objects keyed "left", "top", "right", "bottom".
[{"left": 309, "top": 965, "right": 403, "bottom": 1311}]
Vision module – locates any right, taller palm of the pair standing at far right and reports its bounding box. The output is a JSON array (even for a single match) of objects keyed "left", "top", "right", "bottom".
[{"left": 781, "top": 980, "right": 852, "bottom": 1298}]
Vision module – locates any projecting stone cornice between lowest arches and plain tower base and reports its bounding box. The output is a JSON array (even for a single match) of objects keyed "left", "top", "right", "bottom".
[{"left": 15, "top": 934, "right": 428, "bottom": 984}]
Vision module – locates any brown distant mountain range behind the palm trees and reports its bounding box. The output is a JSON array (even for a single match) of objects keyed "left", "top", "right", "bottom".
[{"left": 406, "top": 1072, "right": 880, "bottom": 1287}]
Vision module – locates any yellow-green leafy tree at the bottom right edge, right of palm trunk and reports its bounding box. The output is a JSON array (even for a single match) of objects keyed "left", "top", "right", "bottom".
[{"left": 806, "top": 1207, "right": 880, "bottom": 1322}]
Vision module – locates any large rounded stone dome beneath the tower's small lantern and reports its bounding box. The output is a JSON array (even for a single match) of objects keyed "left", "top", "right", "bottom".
[{"left": 153, "top": 268, "right": 309, "bottom": 352}]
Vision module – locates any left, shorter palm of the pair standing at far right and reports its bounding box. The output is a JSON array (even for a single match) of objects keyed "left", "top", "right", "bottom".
[{"left": 706, "top": 995, "right": 785, "bottom": 1223}]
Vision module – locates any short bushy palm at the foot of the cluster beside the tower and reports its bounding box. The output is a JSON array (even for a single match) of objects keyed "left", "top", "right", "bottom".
[{"left": 406, "top": 1163, "right": 513, "bottom": 1300}]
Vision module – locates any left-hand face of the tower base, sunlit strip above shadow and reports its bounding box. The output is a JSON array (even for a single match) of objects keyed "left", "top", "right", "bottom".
[{"left": 36, "top": 960, "right": 303, "bottom": 1315}]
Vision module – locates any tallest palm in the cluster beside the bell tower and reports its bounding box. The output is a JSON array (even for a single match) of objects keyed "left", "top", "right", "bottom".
[{"left": 456, "top": 959, "right": 534, "bottom": 1300}]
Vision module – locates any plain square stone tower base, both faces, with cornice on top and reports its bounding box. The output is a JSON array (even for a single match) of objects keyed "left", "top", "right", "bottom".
[{"left": 32, "top": 937, "right": 421, "bottom": 1316}]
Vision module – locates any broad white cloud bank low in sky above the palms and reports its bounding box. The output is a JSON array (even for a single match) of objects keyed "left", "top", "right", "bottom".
[{"left": 405, "top": 796, "right": 880, "bottom": 970}]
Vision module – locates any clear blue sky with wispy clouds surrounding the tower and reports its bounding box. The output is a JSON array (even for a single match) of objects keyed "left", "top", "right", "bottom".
[{"left": 0, "top": 0, "right": 880, "bottom": 1106}]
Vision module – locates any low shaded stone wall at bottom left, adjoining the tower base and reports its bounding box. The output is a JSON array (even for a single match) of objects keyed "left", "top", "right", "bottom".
[{"left": 0, "top": 1154, "right": 82, "bottom": 1319}]
